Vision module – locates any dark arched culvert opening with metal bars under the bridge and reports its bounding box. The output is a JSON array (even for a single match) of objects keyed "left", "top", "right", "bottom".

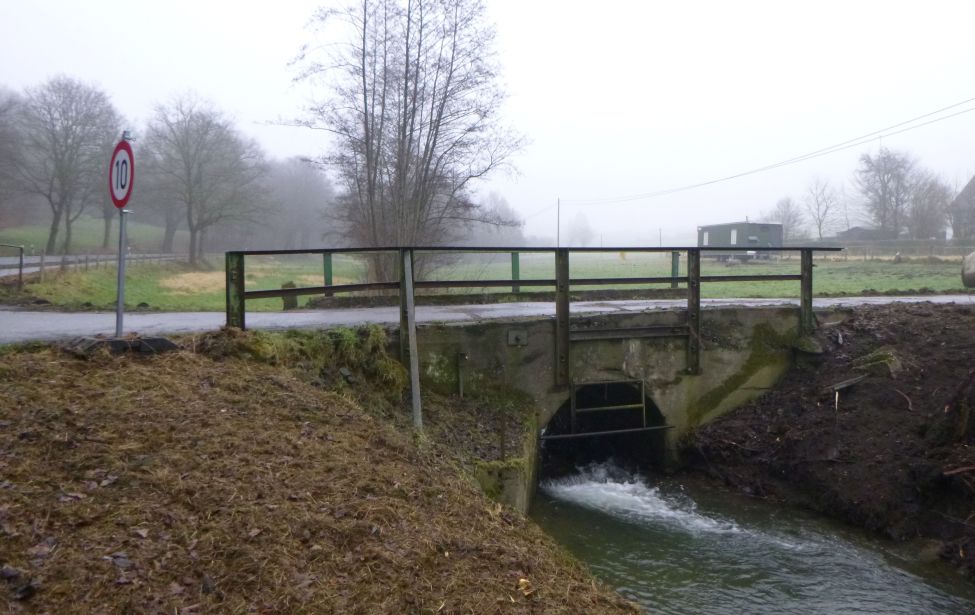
[{"left": 540, "top": 381, "right": 667, "bottom": 479}]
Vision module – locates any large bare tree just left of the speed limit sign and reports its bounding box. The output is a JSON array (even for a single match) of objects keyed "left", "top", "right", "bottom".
[{"left": 14, "top": 76, "right": 122, "bottom": 253}]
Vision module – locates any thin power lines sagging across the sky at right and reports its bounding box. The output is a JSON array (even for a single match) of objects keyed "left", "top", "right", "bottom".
[{"left": 560, "top": 97, "right": 975, "bottom": 205}]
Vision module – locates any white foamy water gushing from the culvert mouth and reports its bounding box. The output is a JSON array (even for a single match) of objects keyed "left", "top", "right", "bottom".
[{"left": 540, "top": 463, "right": 742, "bottom": 534}]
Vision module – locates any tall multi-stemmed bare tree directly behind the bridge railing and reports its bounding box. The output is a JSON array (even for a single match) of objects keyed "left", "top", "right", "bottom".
[{"left": 299, "top": 0, "right": 521, "bottom": 278}]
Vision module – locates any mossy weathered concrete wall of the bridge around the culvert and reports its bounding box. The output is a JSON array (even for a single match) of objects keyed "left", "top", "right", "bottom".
[{"left": 417, "top": 307, "right": 799, "bottom": 458}]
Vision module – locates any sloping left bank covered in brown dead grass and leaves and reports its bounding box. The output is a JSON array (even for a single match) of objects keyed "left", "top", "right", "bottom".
[{"left": 0, "top": 335, "right": 636, "bottom": 614}]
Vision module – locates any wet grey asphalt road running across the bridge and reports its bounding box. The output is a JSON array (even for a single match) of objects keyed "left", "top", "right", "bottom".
[{"left": 0, "top": 294, "right": 975, "bottom": 344}]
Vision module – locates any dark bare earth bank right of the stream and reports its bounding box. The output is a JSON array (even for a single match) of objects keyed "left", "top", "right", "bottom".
[{"left": 687, "top": 304, "right": 975, "bottom": 575}]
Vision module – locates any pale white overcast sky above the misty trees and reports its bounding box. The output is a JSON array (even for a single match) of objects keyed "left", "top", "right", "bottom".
[{"left": 0, "top": 0, "right": 975, "bottom": 245}]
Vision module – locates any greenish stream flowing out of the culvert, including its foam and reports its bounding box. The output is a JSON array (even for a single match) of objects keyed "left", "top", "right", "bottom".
[{"left": 532, "top": 464, "right": 975, "bottom": 615}]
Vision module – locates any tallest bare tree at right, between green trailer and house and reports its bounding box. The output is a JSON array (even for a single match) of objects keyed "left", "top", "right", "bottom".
[{"left": 855, "top": 148, "right": 915, "bottom": 238}]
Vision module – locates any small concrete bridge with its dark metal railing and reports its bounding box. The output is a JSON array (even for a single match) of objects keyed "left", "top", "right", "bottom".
[{"left": 227, "top": 246, "right": 837, "bottom": 476}]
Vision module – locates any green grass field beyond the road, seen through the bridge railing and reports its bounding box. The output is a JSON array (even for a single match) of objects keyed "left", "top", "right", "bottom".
[{"left": 11, "top": 253, "right": 967, "bottom": 311}]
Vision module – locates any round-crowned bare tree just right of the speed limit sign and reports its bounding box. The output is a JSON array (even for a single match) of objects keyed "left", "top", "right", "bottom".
[{"left": 145, "top": 96, "right": 267, "bottom": 265}]
